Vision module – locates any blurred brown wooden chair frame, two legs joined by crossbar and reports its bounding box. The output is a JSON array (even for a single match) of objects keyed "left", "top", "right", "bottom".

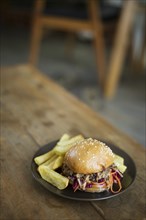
[{"left": 30, "top": 0, "right": 106, "bottom": 91}]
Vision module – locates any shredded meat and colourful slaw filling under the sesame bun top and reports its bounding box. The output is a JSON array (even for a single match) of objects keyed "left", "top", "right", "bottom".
[{"left": 62, "top": 164, "right": 123, "bottom": 193}]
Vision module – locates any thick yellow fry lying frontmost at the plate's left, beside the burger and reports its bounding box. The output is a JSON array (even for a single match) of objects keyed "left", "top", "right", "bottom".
[{"left": 39, "top": 166, "right": 69, "bottom": 190}]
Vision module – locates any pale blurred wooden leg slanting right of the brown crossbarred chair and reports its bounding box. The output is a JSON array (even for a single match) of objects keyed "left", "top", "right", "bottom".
[{"left": 104, "top": 0, "right": 136, "bottom": 99}]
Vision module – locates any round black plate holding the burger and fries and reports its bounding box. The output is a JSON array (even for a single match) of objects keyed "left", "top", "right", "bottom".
[{"left": 31, "top": 141, "right": 136, "bottom": 201}]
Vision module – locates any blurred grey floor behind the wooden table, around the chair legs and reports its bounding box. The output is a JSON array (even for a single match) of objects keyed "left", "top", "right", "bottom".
[{"left": 1, "top": 25, "right": 146, "bottom": 145}]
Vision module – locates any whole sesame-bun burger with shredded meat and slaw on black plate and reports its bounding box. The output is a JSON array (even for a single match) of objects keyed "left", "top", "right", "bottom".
[{"left": 62, "top": 138, "right": 122, "bottom": 193}]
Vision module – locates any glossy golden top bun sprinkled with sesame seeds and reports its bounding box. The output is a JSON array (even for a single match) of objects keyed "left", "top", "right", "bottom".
[{"left": 64, "top": 138, "right": 114, "bottom": 174}]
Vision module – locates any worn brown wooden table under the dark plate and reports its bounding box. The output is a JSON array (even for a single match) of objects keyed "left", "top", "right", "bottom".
[{"left": 1, "top": 65, "right": 145, "bottom": 220}]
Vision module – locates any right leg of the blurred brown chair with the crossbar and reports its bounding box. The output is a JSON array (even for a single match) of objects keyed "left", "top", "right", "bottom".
[{"left": 88, "top": 0, "right": 105, "bottom": 91}]
